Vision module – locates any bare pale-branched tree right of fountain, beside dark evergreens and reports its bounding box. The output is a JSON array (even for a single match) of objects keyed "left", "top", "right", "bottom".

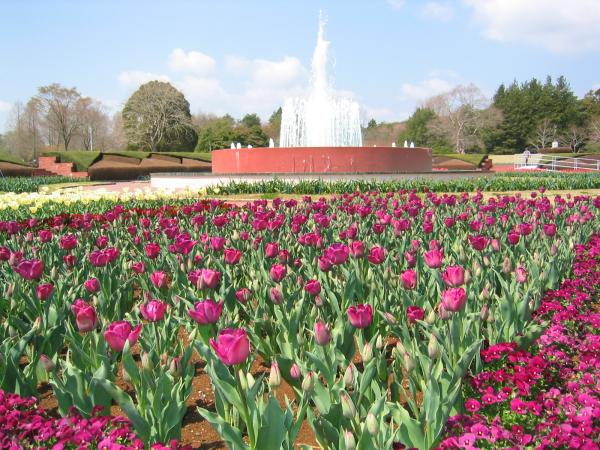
[{"left": 423, "top": 84, "right": 501, "bottom": 153}]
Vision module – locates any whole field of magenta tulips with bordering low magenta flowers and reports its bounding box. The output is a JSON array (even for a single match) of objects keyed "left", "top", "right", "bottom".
[{"left": 0, "top": 188, "right": 600, "bottom": 450}]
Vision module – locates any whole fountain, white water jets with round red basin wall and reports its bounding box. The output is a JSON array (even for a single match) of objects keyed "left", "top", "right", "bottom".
[{"left": 212, "top": 12, "right": 432, "bottom": 176}]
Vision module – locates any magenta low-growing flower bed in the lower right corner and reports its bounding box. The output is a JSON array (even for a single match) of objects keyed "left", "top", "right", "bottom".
[{"left": 440, "top": 235, "right": 600, "bottom": 450}]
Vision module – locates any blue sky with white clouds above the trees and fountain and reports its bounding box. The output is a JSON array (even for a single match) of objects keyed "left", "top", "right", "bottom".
[{"left": 0, "top": 0, "right": 600, "bottom": 132}]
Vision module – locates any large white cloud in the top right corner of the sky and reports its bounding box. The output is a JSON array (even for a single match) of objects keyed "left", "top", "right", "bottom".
[{"left": 463, "top": 0, "right": 600, "bottom": 54}]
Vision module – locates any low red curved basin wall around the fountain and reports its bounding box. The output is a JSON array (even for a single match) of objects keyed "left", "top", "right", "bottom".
[{"left": 212, "top": 147, "right": 431, "bottom": 173}]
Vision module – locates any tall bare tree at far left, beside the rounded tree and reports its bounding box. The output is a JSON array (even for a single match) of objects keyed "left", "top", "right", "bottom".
[{"left": 36, "top": 83, "right": 81, "bottom": 150}]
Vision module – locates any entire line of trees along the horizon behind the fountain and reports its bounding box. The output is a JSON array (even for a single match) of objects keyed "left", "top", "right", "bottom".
[{"left": 0, "top": 77, "right": 600, "bottom": 161}]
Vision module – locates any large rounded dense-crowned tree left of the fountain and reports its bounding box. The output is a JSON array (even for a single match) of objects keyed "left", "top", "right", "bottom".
[{"left": 122, "top": 81, "right": 198, "bottom": 152}]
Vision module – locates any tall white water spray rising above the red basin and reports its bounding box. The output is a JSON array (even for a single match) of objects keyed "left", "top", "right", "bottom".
[{"left": 280, "top": 16, "right": 362, "bottom": 147}]
